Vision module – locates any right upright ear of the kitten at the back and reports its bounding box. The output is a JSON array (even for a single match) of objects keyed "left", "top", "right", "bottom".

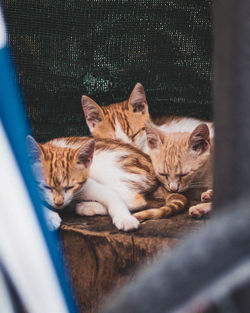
[{"left": 128, "top": 83, "right": 148, "bottom": 114}]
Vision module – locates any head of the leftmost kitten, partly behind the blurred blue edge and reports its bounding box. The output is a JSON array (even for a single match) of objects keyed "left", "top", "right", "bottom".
[{"left": 27, "top": 136, "right": 94, "bottom": 209}]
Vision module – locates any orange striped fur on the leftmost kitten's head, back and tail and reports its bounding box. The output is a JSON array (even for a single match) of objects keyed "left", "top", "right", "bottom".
[{"left": 30, "top": 137, "right": 187, "bottom": 221}]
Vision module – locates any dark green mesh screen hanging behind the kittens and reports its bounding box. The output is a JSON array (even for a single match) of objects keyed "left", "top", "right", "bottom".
[{"left": 2, "top": 0, "right": 212, "bottom": 141}]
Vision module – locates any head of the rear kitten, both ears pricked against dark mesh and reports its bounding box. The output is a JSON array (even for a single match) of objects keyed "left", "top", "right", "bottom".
[{"left": 82, "top": 83, "right": 150, "bottom": 144}]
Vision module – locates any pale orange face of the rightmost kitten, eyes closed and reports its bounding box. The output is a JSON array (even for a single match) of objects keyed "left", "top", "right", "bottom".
[{"left": 146, "top": 124, "right": 210, "bottom": 193}]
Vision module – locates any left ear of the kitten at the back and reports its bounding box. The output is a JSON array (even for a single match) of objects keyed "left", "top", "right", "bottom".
[{"left": 82, "top": 95, "right": 103, "bottom": 131}]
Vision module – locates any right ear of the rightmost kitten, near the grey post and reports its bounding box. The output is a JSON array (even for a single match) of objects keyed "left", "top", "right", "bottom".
[{"left": 188, "top": 123, "right": 210, "bottom": 154}]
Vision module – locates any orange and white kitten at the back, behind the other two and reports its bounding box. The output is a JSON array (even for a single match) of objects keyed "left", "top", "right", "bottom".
[{"left": 82, "top": 83, "right": 213, "bottom": 153}]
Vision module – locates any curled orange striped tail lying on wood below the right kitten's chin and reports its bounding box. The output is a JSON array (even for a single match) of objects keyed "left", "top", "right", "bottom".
[{"left": 133, "top": 193, "right": 188, "bottom": 221}]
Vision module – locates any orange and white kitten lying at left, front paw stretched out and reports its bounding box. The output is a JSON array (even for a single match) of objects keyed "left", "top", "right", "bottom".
[{"left": 27, "top": 136, "right": 186, "bottom": 231}]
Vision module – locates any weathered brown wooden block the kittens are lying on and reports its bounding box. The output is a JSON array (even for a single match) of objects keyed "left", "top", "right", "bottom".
[{"left": 60, "top": 213, "right": 207, "bottom": 313}]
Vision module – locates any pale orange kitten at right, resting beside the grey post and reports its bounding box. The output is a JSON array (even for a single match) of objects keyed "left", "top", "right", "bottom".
[{"left": 140, "top": 123, "right": 213, "bottom": 217}]
